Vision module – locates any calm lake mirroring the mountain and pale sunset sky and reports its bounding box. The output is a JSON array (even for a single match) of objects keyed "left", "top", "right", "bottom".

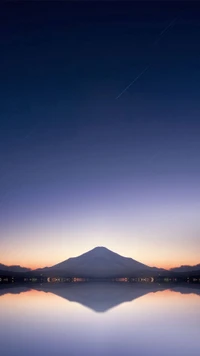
[{"left": 0, "top": 283, "right": 200, "bottom": 356}]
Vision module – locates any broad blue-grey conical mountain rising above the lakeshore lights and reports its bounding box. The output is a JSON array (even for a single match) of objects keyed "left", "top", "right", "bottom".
[{"left": 37, "top": 247, "right": 162, "bottom": 278}]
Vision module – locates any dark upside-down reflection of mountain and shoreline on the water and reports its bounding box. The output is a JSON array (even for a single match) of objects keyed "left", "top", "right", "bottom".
[{"left": 0, "top": 282, "right": 200, "bottom": 312}]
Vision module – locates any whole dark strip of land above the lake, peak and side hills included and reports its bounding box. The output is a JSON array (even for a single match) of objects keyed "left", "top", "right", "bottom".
[{"left": 0, "top": 247, "right": 200, "bottom": 281}]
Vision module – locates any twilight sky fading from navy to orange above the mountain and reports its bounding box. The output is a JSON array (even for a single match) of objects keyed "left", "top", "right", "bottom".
[{"left": 0, "top": 1, "right": 200, "bottom": 268}]
